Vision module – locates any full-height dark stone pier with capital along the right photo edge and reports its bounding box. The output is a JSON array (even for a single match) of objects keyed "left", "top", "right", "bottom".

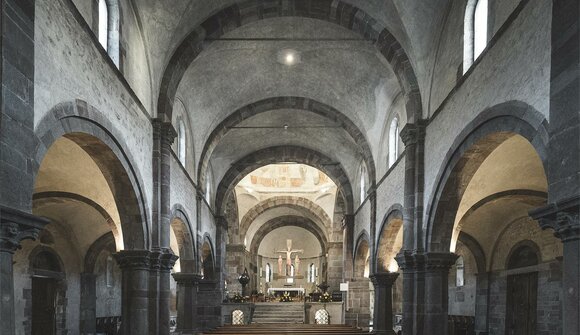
[{"left": 530, "top": 0, "right": 580, "bottom": 335}]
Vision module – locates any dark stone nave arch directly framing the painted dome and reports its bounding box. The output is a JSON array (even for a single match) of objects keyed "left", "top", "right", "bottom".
[{"left": 215, "top": 146, "right": 353, "bottom": 213}]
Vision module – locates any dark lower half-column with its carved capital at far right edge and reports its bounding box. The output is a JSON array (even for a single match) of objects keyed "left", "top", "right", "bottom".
[{"left": 530, "top": 202, "right": 580, "bottom": 334}]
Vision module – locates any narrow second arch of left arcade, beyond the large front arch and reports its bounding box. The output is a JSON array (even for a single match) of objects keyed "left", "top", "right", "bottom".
[{"left": 170, "top": 204, "right": 195, "bottom": 273}]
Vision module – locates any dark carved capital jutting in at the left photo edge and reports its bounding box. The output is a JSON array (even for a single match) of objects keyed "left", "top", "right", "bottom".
[{"left": 0, "top": 206, "right": 50, "bottom": 254}]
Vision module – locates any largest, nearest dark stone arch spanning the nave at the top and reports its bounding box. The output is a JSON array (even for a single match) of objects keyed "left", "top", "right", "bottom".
[{"left": 157, "top": 0, "right": 422, "bottom": 123}]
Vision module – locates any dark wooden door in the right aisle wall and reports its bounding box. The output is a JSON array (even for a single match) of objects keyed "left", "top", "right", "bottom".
[{"left": 505, "top": 272, "right": 538, "bottom": 335}]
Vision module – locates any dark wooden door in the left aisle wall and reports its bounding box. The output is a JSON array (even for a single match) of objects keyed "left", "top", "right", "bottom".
[{"left": 32, "top": 277, "right": 56, "bottom": 335}]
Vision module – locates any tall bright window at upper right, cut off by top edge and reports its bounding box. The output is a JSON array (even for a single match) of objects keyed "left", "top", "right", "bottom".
[{"left": 463, "top": 0, "right": 488, "bottom": 73}]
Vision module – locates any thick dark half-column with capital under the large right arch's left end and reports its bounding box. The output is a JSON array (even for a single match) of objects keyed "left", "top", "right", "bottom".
[{"left": 423, "top": 252, "right": 457, "bottom": 334}]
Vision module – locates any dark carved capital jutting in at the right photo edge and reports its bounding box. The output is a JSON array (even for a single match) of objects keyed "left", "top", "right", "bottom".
[{"left": 529, "top": 197, "right": 580, "bottom": 242}]
